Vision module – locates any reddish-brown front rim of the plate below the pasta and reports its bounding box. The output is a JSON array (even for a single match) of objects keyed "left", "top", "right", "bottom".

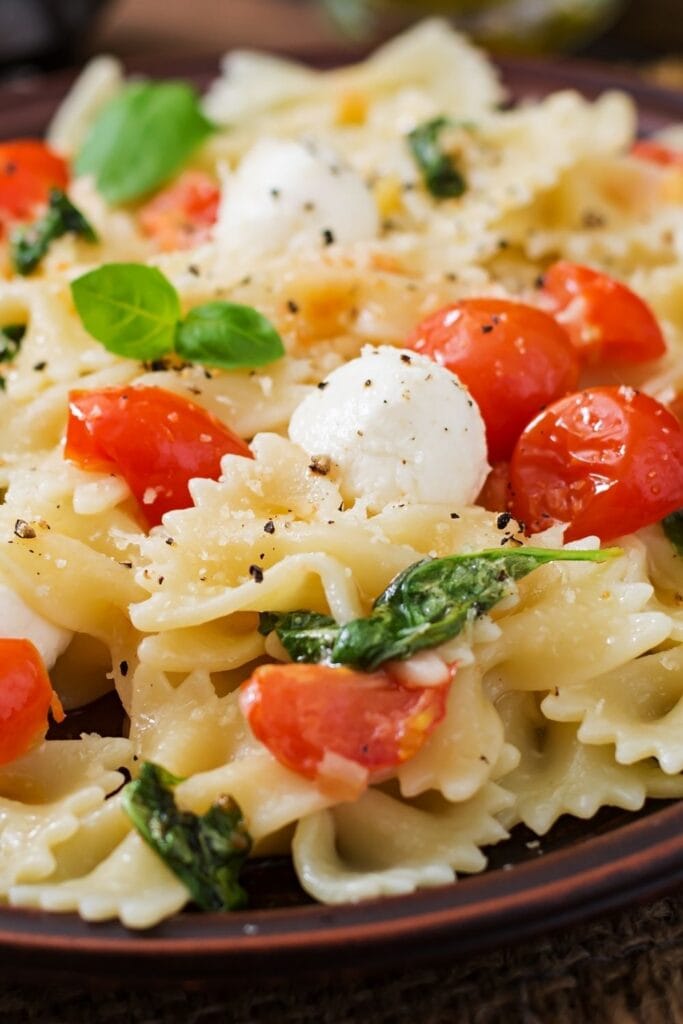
[{"left": 0, "top": 804, "right": 683, "bottom": 978}]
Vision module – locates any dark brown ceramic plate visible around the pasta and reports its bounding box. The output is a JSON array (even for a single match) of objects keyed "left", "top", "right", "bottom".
[{"left": 0, "top": 51, "right": 683, "bottom": 984}]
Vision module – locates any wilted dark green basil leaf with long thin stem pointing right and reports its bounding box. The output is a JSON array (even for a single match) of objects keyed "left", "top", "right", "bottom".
[{"left": 259, "top": 548, "right": 621, "bottom": 672}]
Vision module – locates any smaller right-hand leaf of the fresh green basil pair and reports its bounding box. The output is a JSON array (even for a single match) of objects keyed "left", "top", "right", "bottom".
[{"left": 175, "top": 302, "right": 285, "bottom": 370}]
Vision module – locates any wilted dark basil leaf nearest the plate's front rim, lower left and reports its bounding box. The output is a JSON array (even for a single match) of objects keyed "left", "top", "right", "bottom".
[{"left": 123, "top": 761, "right": 252, "bottom": 910}]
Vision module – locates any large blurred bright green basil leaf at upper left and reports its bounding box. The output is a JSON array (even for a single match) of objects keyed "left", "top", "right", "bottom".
[{"left": 76, "top": 82, "right": 213, "bottom": 203}]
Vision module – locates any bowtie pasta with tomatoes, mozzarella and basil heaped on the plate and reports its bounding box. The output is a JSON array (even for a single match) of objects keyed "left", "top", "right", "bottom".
[{"left": 0, "top": 22, "right": 683, "bottom": 928}]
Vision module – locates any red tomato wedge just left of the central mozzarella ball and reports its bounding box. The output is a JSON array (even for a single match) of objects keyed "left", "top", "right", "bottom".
[{"left": 65, "top": 387, "right": 253, "bottom": 526}]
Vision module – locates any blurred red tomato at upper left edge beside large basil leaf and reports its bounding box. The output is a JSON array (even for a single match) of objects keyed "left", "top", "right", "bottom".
[{"left": 0, "top": 138, "right": 69, "bottom": 225}]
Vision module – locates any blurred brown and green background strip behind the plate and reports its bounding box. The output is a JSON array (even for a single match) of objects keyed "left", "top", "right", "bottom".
[{"left": 0, "top": 0, "right": 683, "bottom": 81}]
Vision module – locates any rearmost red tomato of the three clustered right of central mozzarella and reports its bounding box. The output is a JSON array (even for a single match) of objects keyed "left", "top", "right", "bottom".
[{"left": 543, "top": 261, "right": 667, "bottom": 364}]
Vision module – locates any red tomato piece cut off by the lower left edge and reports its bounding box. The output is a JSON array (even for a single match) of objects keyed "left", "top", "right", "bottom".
[{"left": 0, "top": 637, "right": 65, "bottom": 765}]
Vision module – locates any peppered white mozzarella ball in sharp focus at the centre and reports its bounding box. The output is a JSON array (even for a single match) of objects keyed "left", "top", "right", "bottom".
[{"left": 290, "top": 345, "right": 489, "bottom": 512}]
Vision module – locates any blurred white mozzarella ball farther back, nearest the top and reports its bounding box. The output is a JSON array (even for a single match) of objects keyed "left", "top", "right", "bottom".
[{"left": 215, "top": 138, "right": 379, "bottom": 258}]
